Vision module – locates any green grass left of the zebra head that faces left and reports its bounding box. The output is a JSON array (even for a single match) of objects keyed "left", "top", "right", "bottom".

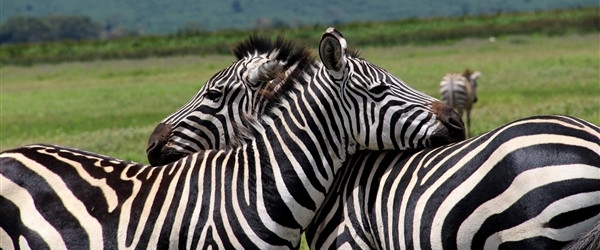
[{"left": 0, "top": 56, "right": 233, "bottom": 162}]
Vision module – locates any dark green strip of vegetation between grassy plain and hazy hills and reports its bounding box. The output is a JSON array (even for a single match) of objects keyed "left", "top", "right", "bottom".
[{"left": 0, "top": 7, "right": 600, "bottom": 67}]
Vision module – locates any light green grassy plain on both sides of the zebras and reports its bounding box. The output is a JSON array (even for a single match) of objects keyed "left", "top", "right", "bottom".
[{"left": 0, "top": 33, "right": 600, "bottom": 162}]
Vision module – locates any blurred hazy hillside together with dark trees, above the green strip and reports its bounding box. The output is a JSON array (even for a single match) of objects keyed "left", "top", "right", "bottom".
[{"left": 0, "top": 0, "right": 599, "bottom": 43}]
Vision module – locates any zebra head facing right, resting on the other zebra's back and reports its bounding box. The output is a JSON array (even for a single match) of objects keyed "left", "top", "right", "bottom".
[{"left": 319, "top": 28, "right": 465, "bottom": 150}]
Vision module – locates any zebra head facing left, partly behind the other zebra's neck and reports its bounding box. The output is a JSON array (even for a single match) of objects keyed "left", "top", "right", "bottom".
[{"left": 146, "top": 36, "right": 314, "bottom": 165}]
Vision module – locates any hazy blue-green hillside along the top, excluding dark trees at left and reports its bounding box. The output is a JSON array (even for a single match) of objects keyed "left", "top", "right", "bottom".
[{"left": 5, "top": 0, "right": 600, "bottom": 34}]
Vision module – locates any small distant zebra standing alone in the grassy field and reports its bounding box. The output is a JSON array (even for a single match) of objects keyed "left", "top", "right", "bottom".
[{"left": 440, "top": 69, "right": 481, "bottom": 137}]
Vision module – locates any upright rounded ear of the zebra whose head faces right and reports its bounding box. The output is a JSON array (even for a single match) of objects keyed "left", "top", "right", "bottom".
[{"left": 319, "top": 28, "right": 347, "bottom": 79}]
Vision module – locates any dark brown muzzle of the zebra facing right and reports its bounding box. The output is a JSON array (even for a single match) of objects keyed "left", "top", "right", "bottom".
[{"left": 431, "top": 101, "right": 466, "bottom": 146}]
